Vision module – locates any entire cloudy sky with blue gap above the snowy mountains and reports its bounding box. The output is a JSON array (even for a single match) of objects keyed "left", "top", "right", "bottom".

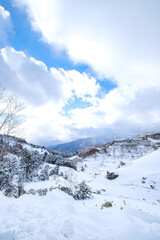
[{"left": 0, "top": 0, "right": 160, "bottom": 145}]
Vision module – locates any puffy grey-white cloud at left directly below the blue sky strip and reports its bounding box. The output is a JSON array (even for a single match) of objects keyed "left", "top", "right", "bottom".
[{"left": 0, "top": 47, "right": 100, "bottom": 107}]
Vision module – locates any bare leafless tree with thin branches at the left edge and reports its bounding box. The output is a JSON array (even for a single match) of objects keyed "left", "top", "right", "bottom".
[{"left": 0, "top": 87, "right": 24, "bottom": 157}]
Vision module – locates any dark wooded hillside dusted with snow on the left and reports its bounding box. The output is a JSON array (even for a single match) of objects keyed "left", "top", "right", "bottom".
[{"left": 0, "top": 135, "right": 76, "bottom": 197}]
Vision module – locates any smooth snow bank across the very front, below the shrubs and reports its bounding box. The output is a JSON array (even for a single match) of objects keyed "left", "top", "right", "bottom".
[{"left": 0, "top": 190, "right": 160, "bottom": 240}]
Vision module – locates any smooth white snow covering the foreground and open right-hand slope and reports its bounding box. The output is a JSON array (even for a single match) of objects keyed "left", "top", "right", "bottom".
[{"left": 0, "top": 150, "right": 160, "bottom": 240}]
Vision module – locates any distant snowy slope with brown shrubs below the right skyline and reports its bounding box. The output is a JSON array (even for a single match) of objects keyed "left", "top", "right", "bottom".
[{"left": 76, "top": 133, "right": 160, "bottom": 160}]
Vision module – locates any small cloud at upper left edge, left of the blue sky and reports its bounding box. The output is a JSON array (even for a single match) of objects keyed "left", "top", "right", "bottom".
[{"left": 0, "top": 6, "right": 12, "bottom": 43}]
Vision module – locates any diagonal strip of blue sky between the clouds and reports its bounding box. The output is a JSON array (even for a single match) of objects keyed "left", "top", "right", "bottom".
[{"left": 0, "top": 0, "right": 116, "bottom": 91}]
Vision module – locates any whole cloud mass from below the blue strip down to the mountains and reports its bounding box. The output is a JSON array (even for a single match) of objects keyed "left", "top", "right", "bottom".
[{"left": 0, "top": 47, "right": 160, "bottom": 145}]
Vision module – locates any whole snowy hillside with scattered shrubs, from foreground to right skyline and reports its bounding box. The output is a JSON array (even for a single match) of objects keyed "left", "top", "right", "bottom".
[{"left": 0, "top": 134, "right": 160, "bottom": 240}]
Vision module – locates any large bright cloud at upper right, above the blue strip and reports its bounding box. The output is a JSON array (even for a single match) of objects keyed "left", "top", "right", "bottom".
[{"left": 14, "top": 0, "right": 160, "bottom": 87}]
